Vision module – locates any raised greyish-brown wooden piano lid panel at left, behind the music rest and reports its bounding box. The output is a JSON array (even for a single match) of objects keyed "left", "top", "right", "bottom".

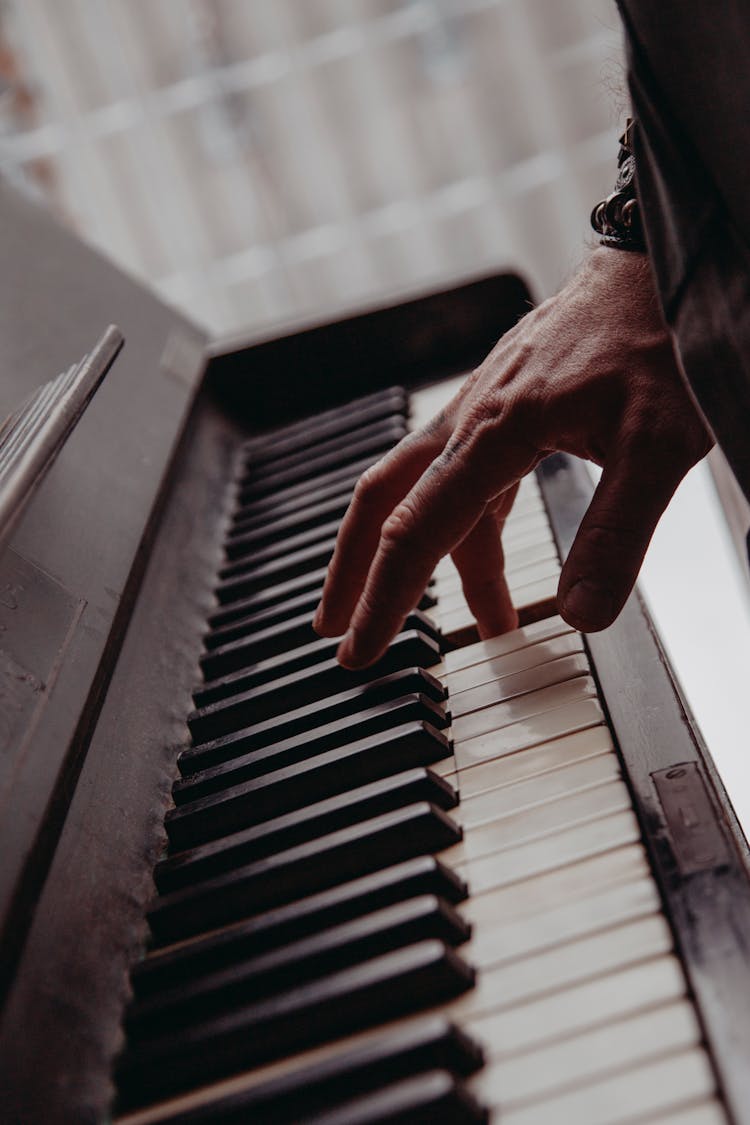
[{"left": 0, "top": 181, "right": 205, "bottom": 998}]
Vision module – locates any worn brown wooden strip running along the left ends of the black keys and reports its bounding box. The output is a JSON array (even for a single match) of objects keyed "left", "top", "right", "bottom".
[{"left": 0, "top": 395, "right": 240, "bottom": 1125}]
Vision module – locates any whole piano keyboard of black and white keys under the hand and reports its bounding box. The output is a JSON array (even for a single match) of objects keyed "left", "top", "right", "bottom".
[{"left": 117, "top": 390, "right": 728, "bottom": 1125}]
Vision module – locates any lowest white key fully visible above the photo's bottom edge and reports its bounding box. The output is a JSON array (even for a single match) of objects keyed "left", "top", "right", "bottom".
[{"left": 469, "top": 1000, "right": 701, "bottom": 1113}]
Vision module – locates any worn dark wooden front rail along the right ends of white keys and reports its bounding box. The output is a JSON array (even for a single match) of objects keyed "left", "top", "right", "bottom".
[{"left": 537, "top": 453, "right": 750, "bottom": 1125}]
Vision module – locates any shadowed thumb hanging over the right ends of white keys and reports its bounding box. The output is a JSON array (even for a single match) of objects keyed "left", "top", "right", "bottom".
[{"left": 558, "top": 460, "right": 685, "bottom": 632}]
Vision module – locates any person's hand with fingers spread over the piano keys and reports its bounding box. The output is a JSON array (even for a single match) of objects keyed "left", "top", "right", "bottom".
[{"left": 314, "top": 249, "right": 713, "bottom": 668}]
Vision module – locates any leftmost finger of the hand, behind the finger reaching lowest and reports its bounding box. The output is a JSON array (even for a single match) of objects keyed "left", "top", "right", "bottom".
[{"left": 313, "top": 425, "right": 445, "bottom": 637}]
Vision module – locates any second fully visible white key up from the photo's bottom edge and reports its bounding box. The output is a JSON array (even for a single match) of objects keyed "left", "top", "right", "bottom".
[{"left": 470, "top": 954, "right": 686, "bottom": 1057}]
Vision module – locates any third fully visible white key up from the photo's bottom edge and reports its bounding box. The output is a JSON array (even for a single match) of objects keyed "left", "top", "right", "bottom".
[{"left": 451, "top": 914, "right": 672, "bottom": 1022}]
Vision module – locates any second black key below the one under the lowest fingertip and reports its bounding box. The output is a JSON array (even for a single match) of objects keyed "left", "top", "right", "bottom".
[{"left": 172, "top": 695, "right": 449, "bottom": 804}]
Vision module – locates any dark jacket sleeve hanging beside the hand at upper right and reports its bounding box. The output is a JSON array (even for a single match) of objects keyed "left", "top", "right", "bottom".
[{"left": 620, "top": 0, "right": 750, "bottom": 497}]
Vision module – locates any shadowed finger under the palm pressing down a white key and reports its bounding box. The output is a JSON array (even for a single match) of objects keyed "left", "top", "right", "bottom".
[{"left": 451, "top": 485, "right": 518, "bottom": 639}]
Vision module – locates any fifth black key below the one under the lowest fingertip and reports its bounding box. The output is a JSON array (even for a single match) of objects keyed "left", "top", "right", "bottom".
[{"left": 148, "top": 802, "right": 461, "bottom": 943}]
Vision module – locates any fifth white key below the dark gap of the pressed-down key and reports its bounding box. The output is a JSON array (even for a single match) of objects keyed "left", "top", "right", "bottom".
[{"left": 454, "top": 698, "right": 604, "bottom": 771}]
